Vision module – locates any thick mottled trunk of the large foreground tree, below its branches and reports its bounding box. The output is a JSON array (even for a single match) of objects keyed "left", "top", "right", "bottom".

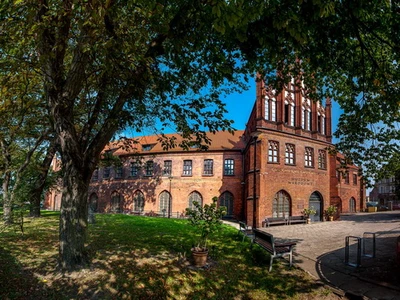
[{"left": 59, "top": 158, "right": 90, "bottom": 270}]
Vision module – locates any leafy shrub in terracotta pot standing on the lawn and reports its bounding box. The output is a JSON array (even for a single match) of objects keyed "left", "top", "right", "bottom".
[{"left": 186, "top": 197, "right": 226, "bottom": 267}]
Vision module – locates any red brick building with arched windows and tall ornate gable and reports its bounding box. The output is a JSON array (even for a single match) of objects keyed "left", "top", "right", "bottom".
[{"left": 47, "top": 81, "right": 365, "bottom": 226}]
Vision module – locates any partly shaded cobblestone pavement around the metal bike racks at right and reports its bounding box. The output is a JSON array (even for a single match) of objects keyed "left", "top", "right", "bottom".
[{"left": 262, "top": 211, "right": 400, "bottom": 300}]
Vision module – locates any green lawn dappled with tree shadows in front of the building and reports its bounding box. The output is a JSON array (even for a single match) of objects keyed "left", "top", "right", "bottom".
[{"left": 0, "top": 212, "right": 335, "bottom": 299}]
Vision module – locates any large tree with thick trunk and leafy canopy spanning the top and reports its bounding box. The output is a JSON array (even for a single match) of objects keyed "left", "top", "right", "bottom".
[{"left": 0, "top": 0, "right": 399, "bottom": 269}]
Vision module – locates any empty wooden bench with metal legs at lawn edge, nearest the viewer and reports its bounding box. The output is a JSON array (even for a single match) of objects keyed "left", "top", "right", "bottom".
[{"left": 252, "top": 229, "right": 296, "bottom": 272}]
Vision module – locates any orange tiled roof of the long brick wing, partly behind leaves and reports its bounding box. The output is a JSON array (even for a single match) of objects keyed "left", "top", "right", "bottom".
[{"left": 104, "top": 130, "right": 245, "bottom": 155}]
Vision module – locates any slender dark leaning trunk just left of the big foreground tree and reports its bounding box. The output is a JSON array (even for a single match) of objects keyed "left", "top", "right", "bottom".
[{"left": 29, "top": 141, "right": 56, "bottom": 218}]
